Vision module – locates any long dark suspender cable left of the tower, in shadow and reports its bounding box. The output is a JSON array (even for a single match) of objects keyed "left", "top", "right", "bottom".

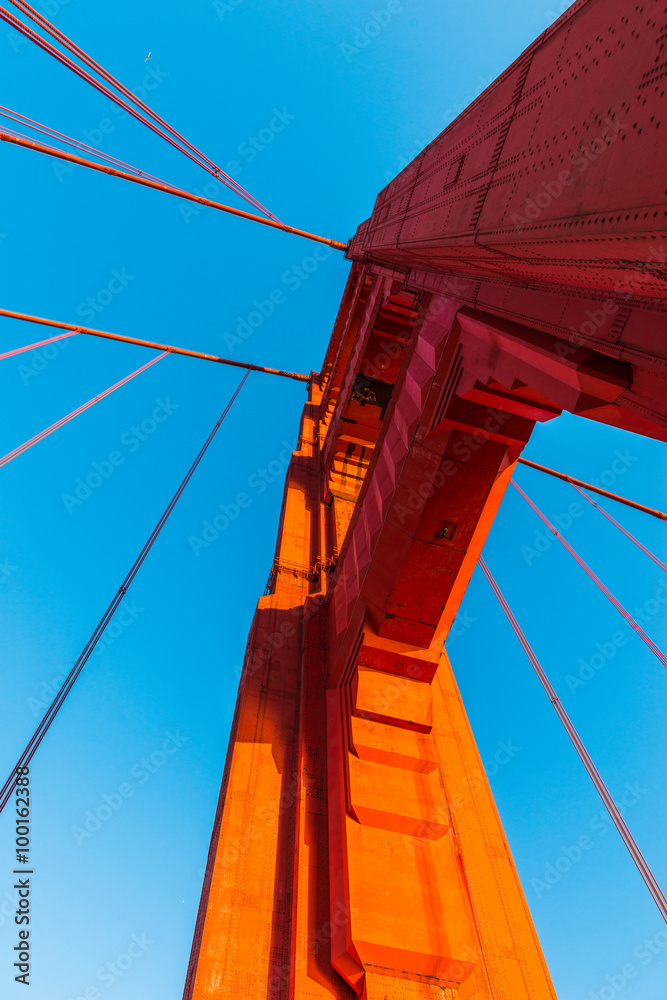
[{"left": 0, "top": 372, "right": 250, "bottom": 812}]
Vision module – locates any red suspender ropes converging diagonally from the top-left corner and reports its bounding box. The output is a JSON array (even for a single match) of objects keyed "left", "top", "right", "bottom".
[{"left": 0, "top": 0, "right": 275, "bottom": 219}]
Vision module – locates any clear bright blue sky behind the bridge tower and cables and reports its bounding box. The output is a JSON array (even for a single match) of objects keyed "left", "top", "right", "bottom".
[{"left": 0, "top": 0, "right": 667, "bottom": 1000}]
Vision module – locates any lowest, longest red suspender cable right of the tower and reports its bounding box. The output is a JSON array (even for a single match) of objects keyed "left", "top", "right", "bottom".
[{"left": 479, "top": 558, "right": 667, "bottom": 921}]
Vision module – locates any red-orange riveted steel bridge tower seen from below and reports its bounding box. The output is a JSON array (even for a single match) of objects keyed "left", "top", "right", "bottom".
[{"left": 184, "top": 0, "right": 667, "bottom": 1000}]
